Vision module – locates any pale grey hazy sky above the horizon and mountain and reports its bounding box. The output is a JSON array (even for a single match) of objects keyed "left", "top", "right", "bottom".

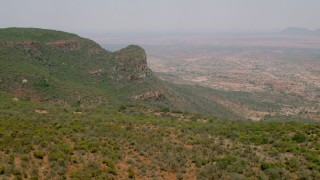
[{"left": 0, "top": 0, "right": 320, "bottom": 33}]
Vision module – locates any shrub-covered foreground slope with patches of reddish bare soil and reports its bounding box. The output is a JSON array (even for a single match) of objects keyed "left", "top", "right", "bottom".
[{"left": 0, "top": 94, "right": 320, "bottom": 179}]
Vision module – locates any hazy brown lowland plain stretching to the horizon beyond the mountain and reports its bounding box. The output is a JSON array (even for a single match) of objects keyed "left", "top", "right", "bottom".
[{"left": 96, "top": 35, "right": 320, "bottom": 120}]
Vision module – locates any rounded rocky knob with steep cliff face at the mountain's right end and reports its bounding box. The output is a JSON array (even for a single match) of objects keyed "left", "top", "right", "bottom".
[{"left": 115, "top": 45, "right": 152, "bottom": 81}]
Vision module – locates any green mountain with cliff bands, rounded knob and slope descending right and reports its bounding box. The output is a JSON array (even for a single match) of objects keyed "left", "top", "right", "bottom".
[{"left": 0, "top": 28, "right": 240, "bottom": 118}]
